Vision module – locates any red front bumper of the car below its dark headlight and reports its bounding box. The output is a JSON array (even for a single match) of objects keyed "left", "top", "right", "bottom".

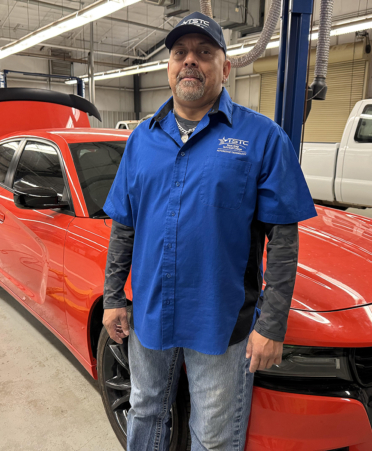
[{"left": 244, "top": 387, "right": 372, "bottom": 451}]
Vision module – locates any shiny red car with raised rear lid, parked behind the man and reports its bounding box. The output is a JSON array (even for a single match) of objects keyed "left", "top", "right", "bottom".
[{"left": 0, "top": 89, "right": 372, "bottom": 451}]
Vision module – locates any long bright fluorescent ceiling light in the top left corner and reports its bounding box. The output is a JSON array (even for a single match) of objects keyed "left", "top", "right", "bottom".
[{"left": 0, "top": 0, "right": 140, "bottom": 59}]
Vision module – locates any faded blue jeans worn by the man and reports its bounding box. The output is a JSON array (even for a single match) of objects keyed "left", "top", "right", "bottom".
[{"left": 127, "top": 329, "right": 253, "bottom": 451}]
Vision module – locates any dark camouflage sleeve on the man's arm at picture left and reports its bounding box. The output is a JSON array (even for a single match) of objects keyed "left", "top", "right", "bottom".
[{"left": 103, "top": 221, "right": 134, "bottom": 309}]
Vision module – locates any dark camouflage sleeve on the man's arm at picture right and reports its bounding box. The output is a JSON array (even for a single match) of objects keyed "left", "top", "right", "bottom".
[{"left": 254, "top": 223, "right": 298, "bottom": 342}]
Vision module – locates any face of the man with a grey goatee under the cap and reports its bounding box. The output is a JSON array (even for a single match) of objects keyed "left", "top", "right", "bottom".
[{"left": 168, "top": 33, "right": 230, "bottom": 103}]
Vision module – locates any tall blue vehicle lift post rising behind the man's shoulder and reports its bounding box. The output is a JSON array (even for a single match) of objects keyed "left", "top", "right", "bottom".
[{"left": 275, "top": 0, "right": 313, "bottom": 157}]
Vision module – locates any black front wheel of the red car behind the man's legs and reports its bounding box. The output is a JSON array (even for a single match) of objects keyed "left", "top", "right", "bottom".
[{"left": 97, "top": 327, "right": 191, "bottom": 451}]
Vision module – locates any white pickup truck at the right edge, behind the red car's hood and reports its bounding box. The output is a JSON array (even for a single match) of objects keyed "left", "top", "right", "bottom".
[{"left": 301, "top": 99, "right": 372, "bottom": 209}]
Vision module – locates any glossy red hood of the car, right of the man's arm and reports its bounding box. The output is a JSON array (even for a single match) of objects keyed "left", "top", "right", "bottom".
[{"left": 291, "top": 207, "right": 372, "bottom": 312}]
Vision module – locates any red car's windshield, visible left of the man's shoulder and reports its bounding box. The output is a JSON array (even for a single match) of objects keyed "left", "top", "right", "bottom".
[{"left": 69, "top": 141, "right": 126, "bottom": 218}]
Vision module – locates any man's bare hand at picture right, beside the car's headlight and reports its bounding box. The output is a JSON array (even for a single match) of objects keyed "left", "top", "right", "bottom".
[{"left": 245, "top": 330, "right": 283, "bottom": 373}]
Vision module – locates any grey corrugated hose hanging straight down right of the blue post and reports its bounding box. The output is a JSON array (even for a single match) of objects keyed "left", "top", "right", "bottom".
[{"left": 310, "top": 0, "right": 333, "bottom": 100}]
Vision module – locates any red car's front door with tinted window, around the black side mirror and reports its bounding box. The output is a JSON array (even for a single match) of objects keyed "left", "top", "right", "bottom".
[{"left": 1, "top": 139, "right": 74, "bottom": 339}]
